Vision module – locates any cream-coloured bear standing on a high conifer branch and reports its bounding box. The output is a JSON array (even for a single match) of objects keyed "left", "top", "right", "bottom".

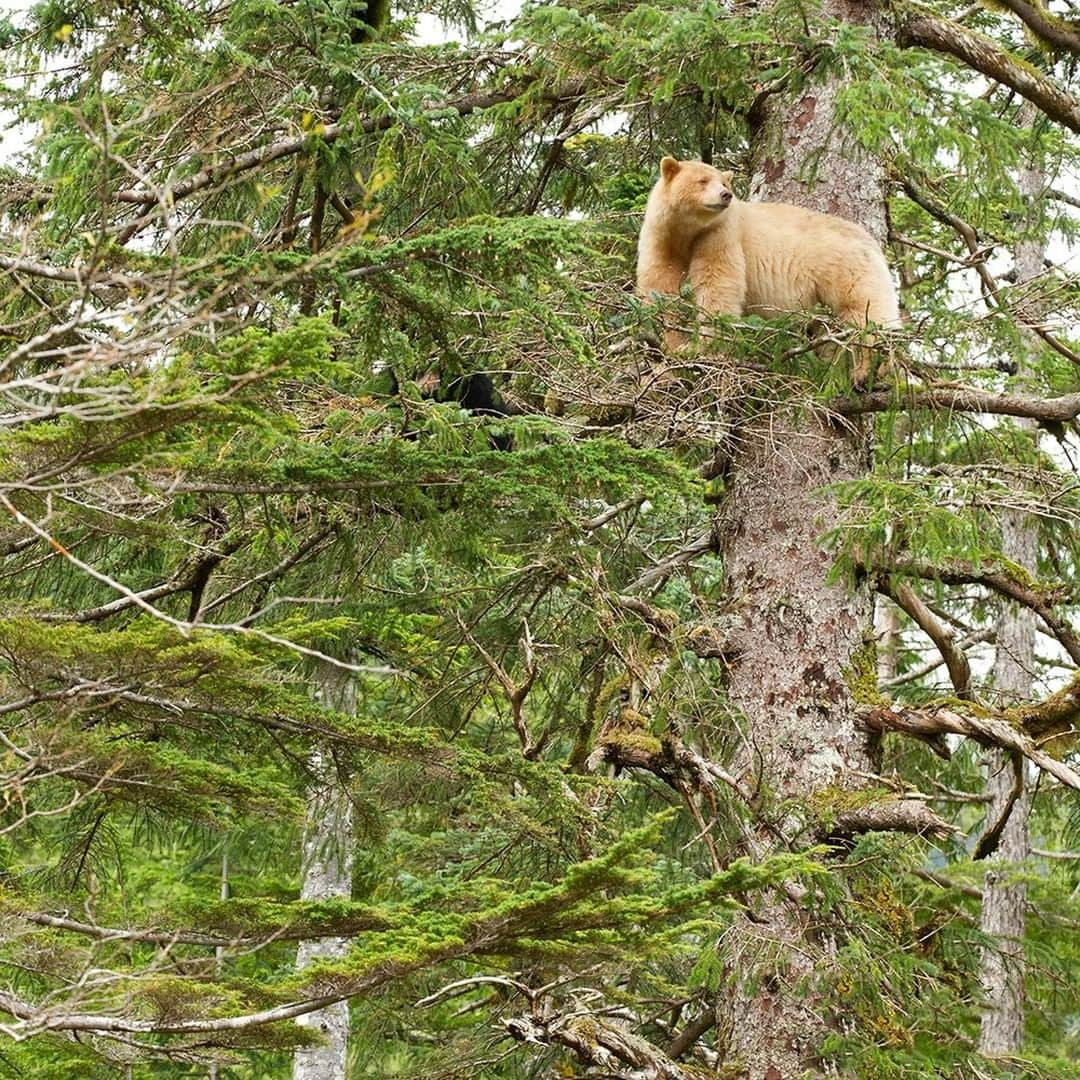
[{"left": 637, "top": 158, "right": 900, "bottom": 386}]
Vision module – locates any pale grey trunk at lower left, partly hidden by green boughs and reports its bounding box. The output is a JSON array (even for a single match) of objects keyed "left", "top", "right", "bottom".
[{"left": 293, "top": 664, "right": 356, "bottom": 1080}]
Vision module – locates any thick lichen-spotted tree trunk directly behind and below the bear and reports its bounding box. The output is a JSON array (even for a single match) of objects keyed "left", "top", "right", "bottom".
[{"left": 718, "top": 0, "right": 886, "bottom": 1080}]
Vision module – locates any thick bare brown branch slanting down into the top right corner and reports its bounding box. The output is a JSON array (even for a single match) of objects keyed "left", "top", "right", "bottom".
[{"left": 896, "top": 8, "right": 1080, "bottom": 134}]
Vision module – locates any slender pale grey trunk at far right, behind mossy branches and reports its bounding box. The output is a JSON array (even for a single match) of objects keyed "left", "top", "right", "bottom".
[{"left": 978, "top": 116, "right": 1044, "bottom": 1055}]
